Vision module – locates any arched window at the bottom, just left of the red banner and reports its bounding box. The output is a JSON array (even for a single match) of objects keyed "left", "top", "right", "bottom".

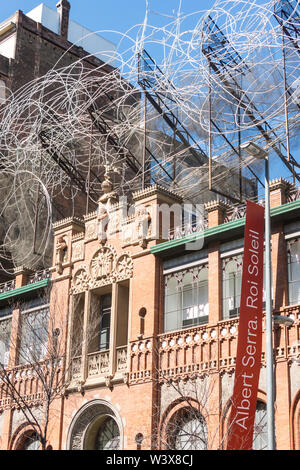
[{"left": 168, "top": 409, "right": 207, "bottom": 450}]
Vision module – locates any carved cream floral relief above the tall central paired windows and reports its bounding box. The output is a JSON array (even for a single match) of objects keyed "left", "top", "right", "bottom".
[{"left": 71, "top": 246, "right": 133, "bottom": 294}]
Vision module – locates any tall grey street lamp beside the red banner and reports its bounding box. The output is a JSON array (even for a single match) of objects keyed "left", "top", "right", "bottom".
[{"left": 241, "top": 142, "right": 275, "bottom": 450}]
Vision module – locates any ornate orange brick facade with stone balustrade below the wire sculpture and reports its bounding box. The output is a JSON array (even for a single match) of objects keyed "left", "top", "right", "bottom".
[{"left": 0, "top": 179, "right": 300, "bottom": 450}]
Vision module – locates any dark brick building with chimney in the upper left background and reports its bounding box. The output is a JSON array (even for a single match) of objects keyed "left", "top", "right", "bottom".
[{"left": 0, "top": 0, "right": 113, "bottom": 92}]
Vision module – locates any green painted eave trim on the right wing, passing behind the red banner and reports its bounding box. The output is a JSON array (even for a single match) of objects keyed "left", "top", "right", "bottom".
[{"left": 150, "top": 200, "right": 300, "bottom": 255}]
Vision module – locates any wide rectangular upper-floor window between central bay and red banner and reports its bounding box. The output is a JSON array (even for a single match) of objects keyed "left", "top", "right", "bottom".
[{"left": 164, "top": 264, "right": 209, "bottom": 332}]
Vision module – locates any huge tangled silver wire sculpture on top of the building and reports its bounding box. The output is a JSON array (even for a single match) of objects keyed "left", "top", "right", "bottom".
[{"left": 0, "top": 0, "right": 300, "bottom": 273}]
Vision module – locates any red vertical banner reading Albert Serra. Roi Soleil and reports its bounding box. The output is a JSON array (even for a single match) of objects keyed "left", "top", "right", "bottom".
[{"left": 227, "top": 201, "right": 265, "bottom": 450}]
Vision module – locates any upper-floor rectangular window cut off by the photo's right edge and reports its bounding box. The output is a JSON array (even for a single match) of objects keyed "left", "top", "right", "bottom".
[{"left": 287, "top": 238, "right": 300, "bottom": 305}]
